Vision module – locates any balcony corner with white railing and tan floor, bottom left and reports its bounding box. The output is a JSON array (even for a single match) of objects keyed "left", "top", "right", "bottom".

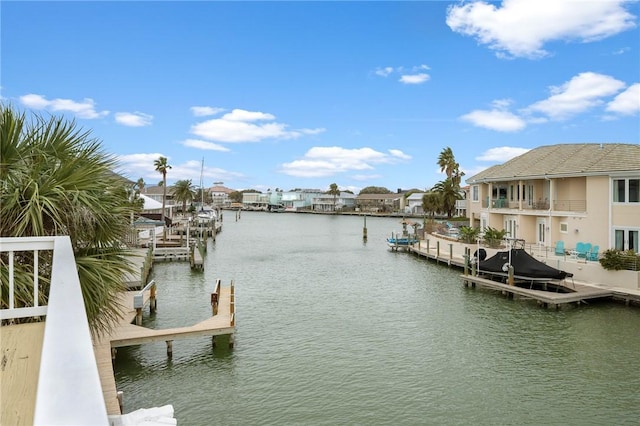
[{"left": 0, "top": 237, "right": 109, "bottom": 425}]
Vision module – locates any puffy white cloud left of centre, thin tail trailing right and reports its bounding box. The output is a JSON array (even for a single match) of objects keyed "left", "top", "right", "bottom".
[{"left": 191, "top": 109, "right": 325, "bottom": 143}]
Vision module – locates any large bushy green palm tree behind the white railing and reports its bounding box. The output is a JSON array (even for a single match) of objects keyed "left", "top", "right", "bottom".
[{"left": 0, "top": 105, "right": 135, "bottom": 333}]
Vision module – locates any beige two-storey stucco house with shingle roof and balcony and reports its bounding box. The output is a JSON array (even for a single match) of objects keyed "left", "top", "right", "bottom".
[{"left": 466, "top": 143, "right": 640, "bottom": 253}]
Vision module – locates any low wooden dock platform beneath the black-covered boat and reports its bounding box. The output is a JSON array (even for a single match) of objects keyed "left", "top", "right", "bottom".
[{"left": 461, "top": 275, "right": 614, "bottom": 309}]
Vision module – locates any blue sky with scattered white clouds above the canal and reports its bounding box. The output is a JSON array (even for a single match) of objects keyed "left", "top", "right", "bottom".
[{"left": 0, "top": 0, "right": 640, "bottom": 193}]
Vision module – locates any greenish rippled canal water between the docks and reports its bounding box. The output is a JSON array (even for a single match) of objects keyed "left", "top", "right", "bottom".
[{"left": 115, "top": 211, "right": 640, "bottom": 425}]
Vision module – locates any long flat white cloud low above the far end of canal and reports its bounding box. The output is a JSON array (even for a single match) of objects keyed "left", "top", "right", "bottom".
[{"left": 280, "top": 146, "right": 410, "bottom": 177}]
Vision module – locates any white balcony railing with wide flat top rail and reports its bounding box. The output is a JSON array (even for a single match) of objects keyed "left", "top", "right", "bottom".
[{"left": 0, "top": 236, "right": 109, "bottom": 425}]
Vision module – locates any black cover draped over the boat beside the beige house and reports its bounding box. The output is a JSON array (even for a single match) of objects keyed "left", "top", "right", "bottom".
[{"left": 479, "top": 249, "right": 573, "bottom": 280}]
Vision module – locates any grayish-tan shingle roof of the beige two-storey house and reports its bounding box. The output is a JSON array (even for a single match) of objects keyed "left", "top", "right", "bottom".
[{"left": 466, "top": 143, "right": 640, "bottom": 183}]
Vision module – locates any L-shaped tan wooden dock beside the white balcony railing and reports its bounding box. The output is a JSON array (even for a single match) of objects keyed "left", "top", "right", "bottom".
[{"left": 94, "top": 280, "right": 235, "bottom": 415}]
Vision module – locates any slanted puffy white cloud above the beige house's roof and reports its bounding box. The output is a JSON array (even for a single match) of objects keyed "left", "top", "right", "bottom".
[{"left": 526, "top": 72, "right": 625, "bottom": 120}]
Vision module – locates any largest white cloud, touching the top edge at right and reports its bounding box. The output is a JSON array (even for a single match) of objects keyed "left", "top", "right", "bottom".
[{"left": 446, "top": 0, "right": 636, "bottom": 58}]
